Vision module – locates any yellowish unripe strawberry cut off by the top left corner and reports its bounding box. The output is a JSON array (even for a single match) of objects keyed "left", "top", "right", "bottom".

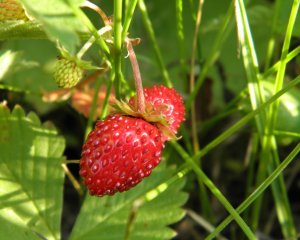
[{"left": 0, "top": 0, "right": 28, "bottom": 21}]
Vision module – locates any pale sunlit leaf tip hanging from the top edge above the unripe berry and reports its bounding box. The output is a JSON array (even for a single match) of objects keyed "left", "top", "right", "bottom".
[{"left": 21, "top": 0, "right": 86, "bottom": 54}]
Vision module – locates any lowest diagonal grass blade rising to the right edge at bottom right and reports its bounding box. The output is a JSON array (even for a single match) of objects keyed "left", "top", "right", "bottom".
[{"left": 206, "top": 143, "right": 300, "bottom": 240}]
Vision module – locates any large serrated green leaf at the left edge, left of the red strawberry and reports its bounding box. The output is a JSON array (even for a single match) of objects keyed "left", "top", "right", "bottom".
[{"left": 0, "top": 105, "right": 65, "bottom": 240}]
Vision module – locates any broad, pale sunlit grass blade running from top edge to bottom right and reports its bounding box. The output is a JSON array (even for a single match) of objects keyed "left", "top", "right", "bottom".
[{"left": 236, "top": 0, "right": 295, "bottom": 237}]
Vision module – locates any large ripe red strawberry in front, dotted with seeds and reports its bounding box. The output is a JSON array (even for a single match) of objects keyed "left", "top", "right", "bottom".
[{"left": 80, "top": 114, "right": 163, "bottom": 196}]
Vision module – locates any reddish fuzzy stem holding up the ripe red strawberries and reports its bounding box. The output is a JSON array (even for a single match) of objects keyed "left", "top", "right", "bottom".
[{"left": 126, "top": 39, "right": 145, "bottom": 113}]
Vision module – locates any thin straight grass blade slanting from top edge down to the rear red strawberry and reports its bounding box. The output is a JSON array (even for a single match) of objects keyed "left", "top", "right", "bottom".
[{"left": 138, "top": 0, "right": 173, "bottom": 87}]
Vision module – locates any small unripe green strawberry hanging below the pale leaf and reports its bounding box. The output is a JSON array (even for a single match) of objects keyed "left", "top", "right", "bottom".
[{"left": 54, "top": 58, "right": 83, "bottom": 88}]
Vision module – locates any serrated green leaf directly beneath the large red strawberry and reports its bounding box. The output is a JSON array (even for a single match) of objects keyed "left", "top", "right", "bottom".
[{"left": 70, "top": 164, "right": 187, "bottom": 240}]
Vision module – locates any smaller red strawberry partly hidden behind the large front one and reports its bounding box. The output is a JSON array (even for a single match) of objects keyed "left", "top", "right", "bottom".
[{"left": 129, "top": 85, "right": 185, "bottom": 140}]
